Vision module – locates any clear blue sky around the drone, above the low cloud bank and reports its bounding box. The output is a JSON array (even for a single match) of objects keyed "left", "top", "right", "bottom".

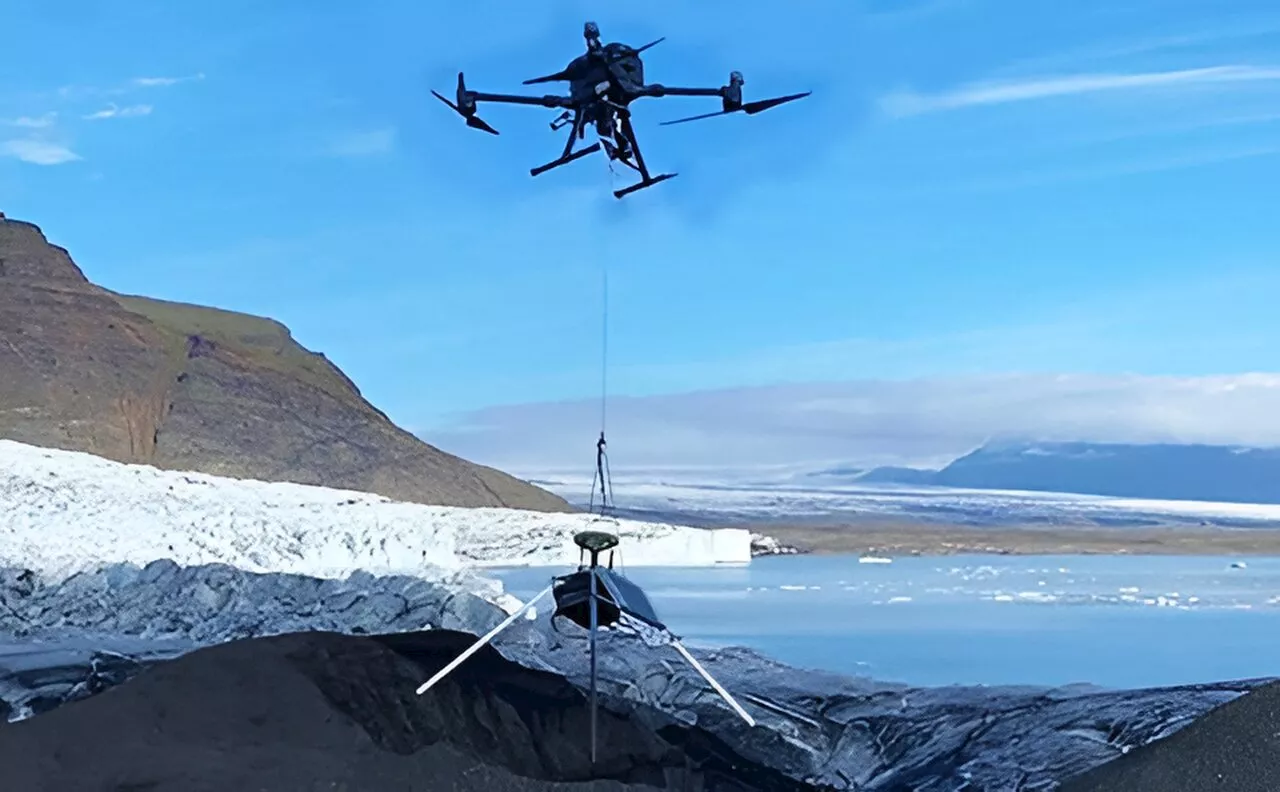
[{"left": 0, "top": 0, "right": 1280, "bottom": 463}]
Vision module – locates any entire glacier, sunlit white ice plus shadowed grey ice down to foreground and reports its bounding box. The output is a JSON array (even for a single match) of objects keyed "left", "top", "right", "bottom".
[{"left": 0, "top": 441, "right": 1258, "bottom": 792}]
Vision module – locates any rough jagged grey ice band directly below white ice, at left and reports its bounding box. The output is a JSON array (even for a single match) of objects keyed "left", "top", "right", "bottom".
[{"left": 0, "top": 560, "right": 504, "bottom": 645}]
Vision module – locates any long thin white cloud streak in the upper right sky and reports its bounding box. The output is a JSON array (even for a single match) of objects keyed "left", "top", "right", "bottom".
[{"left": 881, "top": 65, "right": 1280, "bottom": 118}]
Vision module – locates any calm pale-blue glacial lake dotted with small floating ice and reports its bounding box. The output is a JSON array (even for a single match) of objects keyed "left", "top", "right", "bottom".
[{"left": 498, "top": 555, "right": 1280, "bottom": 687}]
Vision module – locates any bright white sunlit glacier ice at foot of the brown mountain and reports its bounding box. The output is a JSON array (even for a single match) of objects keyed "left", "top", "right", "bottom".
[{"left": 0, "top": 440, "right": 750, "bottom": 588}]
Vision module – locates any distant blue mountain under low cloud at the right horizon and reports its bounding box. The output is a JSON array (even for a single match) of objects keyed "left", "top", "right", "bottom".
[{"left": 809, "top": 443, "right": 1280, "bottom": 503}]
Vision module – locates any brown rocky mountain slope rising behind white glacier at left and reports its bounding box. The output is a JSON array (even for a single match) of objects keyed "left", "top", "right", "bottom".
[{"left": 0, "top": 214, "right": 570, "bottom": 511}]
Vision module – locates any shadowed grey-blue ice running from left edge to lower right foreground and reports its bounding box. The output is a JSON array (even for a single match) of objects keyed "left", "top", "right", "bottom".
[{"left": 0, "top": 562, "right": 1262, "bottom": 792}]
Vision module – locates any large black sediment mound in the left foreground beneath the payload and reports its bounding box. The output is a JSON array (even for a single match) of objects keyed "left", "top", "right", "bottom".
[{"left": 0, "top": 631, "right": 806, "bottom": 792}]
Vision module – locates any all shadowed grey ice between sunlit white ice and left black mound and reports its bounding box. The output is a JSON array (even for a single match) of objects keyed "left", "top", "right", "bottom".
[{"left": 0, "top": 560, "right": 504, "bottom": 720}]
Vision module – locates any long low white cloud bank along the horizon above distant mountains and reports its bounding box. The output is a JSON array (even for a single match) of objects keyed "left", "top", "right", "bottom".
[{"left": 422, "top": 374, "right": 1280, "bottom": 472}]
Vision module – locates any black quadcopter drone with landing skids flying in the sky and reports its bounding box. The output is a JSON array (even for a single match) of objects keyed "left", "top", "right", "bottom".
[{"left": 431, "top": 22, "right": 812, "bottom": 198}]
